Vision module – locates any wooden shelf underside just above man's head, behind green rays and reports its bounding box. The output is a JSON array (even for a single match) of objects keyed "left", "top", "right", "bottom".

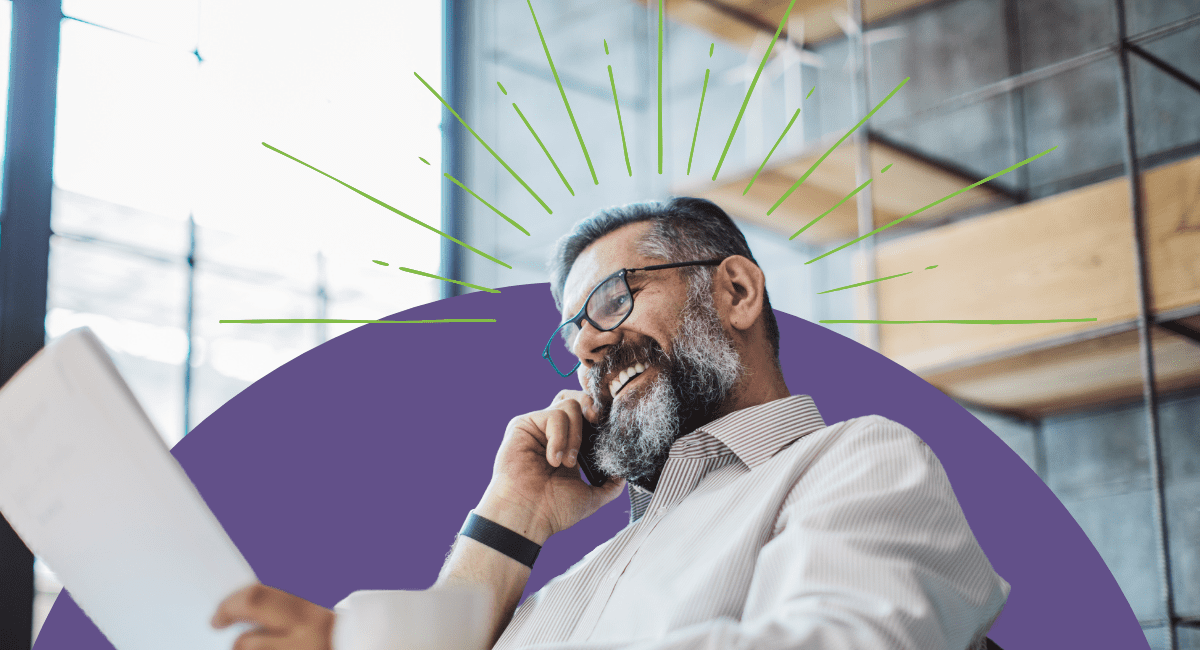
[{"left": 674, "top": 133, "right": 1004, "bottom": 244}]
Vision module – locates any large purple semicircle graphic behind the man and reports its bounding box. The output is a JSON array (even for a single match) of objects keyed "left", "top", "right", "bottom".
[{"left": 36, "top": 284, "right": 1147, "bottom": 650}]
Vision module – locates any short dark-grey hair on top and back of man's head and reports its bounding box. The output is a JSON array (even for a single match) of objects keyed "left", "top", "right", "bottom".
[{"left": 548, "top": 197, "right": 779, "bottom": 363}]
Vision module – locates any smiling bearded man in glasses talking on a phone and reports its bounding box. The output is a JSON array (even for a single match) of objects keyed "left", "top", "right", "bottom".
[{"left": 215, "top": 198, "right": 1009, "bottom": 650}]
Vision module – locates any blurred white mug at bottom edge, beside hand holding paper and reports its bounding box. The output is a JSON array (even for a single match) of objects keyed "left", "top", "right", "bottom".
[{"left": 334, "top": 586, "right": 487, "bottom": 650}]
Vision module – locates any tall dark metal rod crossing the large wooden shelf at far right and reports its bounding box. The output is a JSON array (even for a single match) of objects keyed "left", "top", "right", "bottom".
[{"left": 1114, "top": 0, "right": 1178, "bottom": 650}]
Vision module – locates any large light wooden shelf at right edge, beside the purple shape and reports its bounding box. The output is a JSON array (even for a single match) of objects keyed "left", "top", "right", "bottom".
[{"left": 857, "top": 158, "right": 1200, "bottom": 416}]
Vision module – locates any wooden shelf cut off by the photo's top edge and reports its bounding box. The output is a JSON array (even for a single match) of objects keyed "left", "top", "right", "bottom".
[{"left": 638, "top": 0, "right": 932, "bottom": 49}]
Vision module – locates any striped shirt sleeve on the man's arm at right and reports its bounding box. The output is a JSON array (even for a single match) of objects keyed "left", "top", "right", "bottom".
[{"left": 506, "top": 416, "right": 1009, "bottom": 650}]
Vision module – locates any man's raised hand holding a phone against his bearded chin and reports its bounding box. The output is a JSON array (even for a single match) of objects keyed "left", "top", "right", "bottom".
[{"left": 475, "top": 391, "right": 625, "bottom": 544}]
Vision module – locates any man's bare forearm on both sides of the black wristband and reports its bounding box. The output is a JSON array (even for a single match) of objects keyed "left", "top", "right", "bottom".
[{"left": 434, "top": 494, "right": 550, "bottom": 648}]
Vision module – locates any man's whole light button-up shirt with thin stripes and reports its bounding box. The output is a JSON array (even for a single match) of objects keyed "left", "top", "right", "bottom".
[{"left": 496, "top": 396, "right": 1009, "bottom": 650}]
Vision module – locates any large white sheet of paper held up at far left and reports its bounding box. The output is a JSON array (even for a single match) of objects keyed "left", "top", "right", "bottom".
[{"left": 0, "top": 329, "right": 256, "bottom": 650}]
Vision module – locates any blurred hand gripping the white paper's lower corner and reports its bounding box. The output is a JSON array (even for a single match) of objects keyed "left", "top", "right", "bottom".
[{"left": 212, "top": 583, "right": 334, "bottom": 650}]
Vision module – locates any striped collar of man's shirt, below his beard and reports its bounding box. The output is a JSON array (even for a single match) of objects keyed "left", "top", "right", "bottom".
[{"left": 671, "top": 395, "right": 826, "bottom": 469}]
